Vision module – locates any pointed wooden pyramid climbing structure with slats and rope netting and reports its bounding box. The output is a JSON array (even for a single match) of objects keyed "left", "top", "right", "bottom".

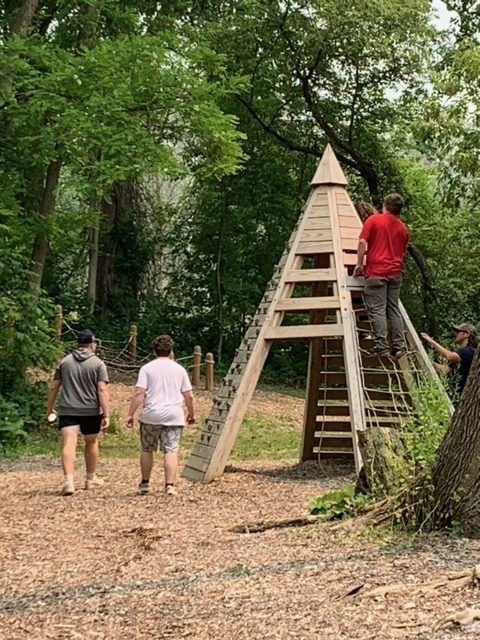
[{"left": 183, "top": 145, "right": 450, "bottom": 482}]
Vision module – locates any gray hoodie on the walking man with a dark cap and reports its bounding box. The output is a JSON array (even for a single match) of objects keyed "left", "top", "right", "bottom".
[{"left": 54, "top": 347, "right": 108, "bottom": 416}]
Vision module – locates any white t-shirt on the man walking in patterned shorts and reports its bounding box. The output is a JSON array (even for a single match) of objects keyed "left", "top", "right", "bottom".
[{"left": 136, "top": 358, "right": 192, "bottom": 427}]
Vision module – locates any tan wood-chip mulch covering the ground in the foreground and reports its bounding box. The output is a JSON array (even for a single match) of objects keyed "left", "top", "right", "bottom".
[{"left": 0, "top": 384, "right": 480, "bottom": 640}]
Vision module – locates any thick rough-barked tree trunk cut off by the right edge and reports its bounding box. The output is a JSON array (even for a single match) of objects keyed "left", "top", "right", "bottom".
[{"left": 433, "top": 350, "right": 480, "bottom": 537}]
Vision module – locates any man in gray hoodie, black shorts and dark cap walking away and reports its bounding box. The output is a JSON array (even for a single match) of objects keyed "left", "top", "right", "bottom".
[{"left": 47, "top": 330, "right": 109, "bottom": 496}]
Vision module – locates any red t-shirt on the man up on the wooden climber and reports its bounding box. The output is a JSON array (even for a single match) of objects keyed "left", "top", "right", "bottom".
[{"left": 360, "top": 213, "right": 408, "bottom": 278}]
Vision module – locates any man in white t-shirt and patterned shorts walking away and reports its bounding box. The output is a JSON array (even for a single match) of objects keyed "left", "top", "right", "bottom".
[{"left": 127, "top": 336, "right": 195, "bottom": 495}]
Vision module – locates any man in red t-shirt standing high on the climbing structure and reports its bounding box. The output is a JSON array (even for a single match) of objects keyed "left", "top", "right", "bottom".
[{"left": 353, "top": 193, "right": 408, "bottom": 358}]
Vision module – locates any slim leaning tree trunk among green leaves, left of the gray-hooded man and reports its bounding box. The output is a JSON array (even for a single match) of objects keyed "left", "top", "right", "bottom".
[{"left": 29, "top": 159, "right": 62, "bottom": 296}]
